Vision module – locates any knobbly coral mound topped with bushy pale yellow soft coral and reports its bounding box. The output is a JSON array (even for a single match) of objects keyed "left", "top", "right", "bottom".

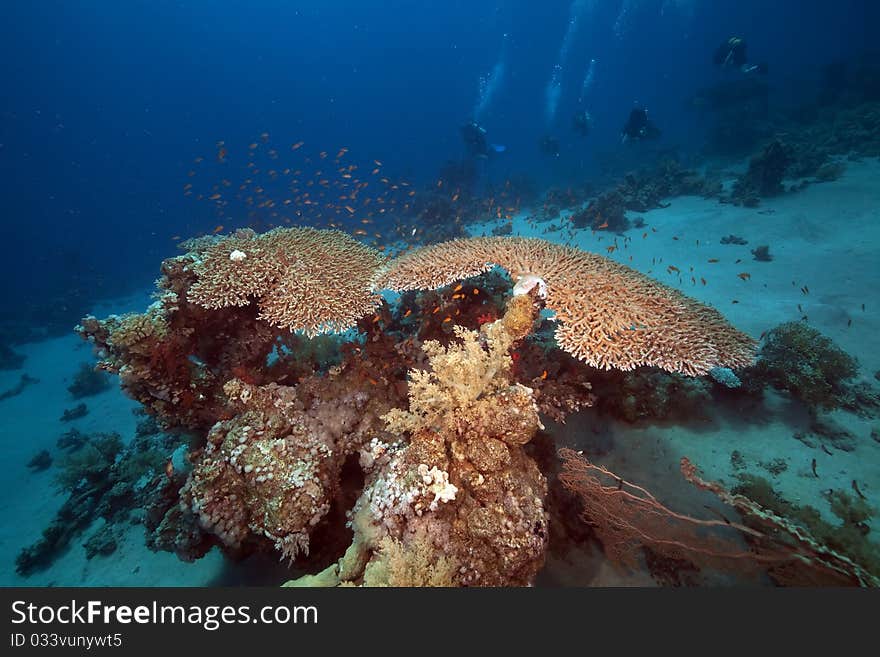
[{"left": 288, "top": 294, "right": 548, "bottom": 586}]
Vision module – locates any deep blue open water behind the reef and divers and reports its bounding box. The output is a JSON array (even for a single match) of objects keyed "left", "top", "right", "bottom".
[{"left": 0, "top": 0, "right": 880, "bottom": 584}]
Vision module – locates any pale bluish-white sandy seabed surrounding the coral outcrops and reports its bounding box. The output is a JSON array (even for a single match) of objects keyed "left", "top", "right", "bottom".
[{"left": 0, "top": 161, "right": 880, "bottom": 586}]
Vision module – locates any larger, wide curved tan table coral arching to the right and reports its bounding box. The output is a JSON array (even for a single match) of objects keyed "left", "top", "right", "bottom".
[{"left": 378, "top": 237, "right": 755, "bottom": 375}]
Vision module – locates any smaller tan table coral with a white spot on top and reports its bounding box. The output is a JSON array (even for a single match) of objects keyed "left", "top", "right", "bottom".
[{"left": 187, "top": 228, "right": 383, "bottom": 336}]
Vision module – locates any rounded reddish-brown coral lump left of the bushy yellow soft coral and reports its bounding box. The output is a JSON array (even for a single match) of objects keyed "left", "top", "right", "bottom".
[{"left": 181, "top": 368, "right": 393, "bottom": 560}]
